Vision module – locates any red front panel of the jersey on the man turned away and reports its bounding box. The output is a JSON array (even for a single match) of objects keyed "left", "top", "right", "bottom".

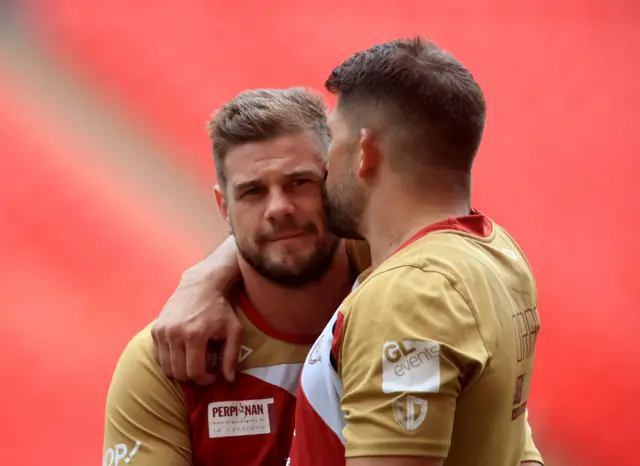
[{"left": 289, "top": 384, "right": 345, "bottom": 466}]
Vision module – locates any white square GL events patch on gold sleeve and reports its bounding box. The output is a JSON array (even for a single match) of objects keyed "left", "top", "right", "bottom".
[{"left": 382, "top": 340, "right": 440, "bottom": 393}]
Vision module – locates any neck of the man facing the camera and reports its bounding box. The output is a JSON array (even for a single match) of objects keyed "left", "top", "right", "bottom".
[{"left": 240, "top": 244, "right": 353, "bottom": 338}]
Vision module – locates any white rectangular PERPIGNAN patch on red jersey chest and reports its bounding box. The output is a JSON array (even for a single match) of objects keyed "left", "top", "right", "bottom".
[{"left": 207, "top": 398, "right": 273, "bottom": 438}]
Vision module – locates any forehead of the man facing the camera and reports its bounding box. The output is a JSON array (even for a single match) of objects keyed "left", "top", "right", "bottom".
[{"left": 225, "top": 131, "right": 324, "bottom": 184}]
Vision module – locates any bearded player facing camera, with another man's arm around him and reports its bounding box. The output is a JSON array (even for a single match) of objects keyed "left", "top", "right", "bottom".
[{"left": 103, "top": 89, "right": 357, "bottom": 466}]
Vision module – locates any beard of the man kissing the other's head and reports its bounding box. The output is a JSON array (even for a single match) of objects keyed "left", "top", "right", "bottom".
[{"left": 323, "top": 168, "right": 366, "bottom": 240}]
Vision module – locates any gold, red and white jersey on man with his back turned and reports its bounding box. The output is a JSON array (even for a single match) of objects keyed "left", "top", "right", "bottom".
[{"left": 291, "top": 211, "right": 542, "bottom": 466}]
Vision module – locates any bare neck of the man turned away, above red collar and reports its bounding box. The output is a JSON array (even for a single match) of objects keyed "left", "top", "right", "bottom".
[{"left": 362, "top": 171, "right": 471, "bottom": 269}]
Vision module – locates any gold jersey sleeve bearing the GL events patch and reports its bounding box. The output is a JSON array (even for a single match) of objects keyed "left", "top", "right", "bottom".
[{"left": 338, "top": 267, "right": 488, "bottom": 458}]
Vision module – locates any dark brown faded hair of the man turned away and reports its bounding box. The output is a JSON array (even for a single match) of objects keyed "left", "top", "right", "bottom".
[{"left": 325, "top": 37, "right": 486, "bottom": 172}]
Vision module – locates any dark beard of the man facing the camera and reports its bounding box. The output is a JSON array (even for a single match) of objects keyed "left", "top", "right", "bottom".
[{"left": 232, "top": 218, "right": 340, "bottom": 288}]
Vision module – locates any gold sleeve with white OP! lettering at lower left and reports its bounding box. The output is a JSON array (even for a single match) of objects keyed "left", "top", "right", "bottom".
[{"left": 102, "top": 328, "right": 192, "bottom": 466}]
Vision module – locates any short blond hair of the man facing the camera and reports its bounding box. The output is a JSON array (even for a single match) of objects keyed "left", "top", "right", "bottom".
[{"left": 207, "top": 88, "right": 330, "bottom": 190}]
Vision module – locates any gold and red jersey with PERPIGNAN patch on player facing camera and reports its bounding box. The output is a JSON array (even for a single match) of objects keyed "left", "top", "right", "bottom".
[{"left": 103, "top": 294, "right": 316, "bottom": 466}]
